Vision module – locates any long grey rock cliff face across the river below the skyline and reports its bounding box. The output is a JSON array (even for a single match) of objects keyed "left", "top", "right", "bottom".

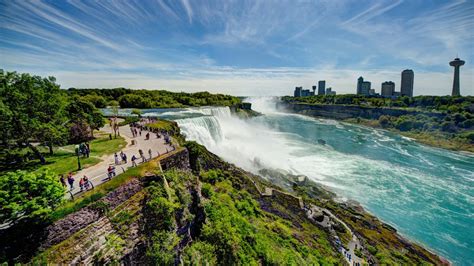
[{"left": 278, "top": 102, "right": 446, "bottom": 119}]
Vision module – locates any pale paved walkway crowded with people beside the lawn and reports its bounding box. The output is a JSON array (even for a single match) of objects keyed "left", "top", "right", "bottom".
[{"left": 66, "top": 124, "right": 173, "bottom": 198}]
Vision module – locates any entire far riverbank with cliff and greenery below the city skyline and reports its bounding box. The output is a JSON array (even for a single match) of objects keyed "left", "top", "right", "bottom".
[{"left": 281, "top": 94, "right": 474, "bottom": 152}]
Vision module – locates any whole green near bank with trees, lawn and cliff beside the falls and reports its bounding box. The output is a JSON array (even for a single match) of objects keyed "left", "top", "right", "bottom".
[{"left": 0, "top": 72, "right": 447, "bottom": 265}]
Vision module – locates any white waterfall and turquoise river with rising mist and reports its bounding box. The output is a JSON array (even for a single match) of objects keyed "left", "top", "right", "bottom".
[{"left": 110, "top": 98, "right": 474, "bottom": 265}]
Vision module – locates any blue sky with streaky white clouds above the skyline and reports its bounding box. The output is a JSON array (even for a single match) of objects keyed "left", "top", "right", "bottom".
[{"left": 0, "top": 0, "right": 474, "bottom": 95}]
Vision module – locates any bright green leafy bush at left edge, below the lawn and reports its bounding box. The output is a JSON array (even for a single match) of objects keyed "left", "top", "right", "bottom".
[{"left": 0, "top": 171, "right": 64, "bottom": 224}]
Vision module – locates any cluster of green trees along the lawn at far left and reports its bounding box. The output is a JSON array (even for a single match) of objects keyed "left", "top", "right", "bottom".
[{"left": 0, "top": 70, "right": 105, "bottom": 167}]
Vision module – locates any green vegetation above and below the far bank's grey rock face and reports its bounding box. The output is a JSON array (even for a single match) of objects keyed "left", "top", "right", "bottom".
[{"left": 282, "top": 94, "right": 474, "bottom": 152}]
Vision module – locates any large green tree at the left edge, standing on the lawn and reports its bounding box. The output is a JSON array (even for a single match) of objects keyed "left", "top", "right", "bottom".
[{"left": 0, "top": 72, "right": 67, "bottom": 164}]
